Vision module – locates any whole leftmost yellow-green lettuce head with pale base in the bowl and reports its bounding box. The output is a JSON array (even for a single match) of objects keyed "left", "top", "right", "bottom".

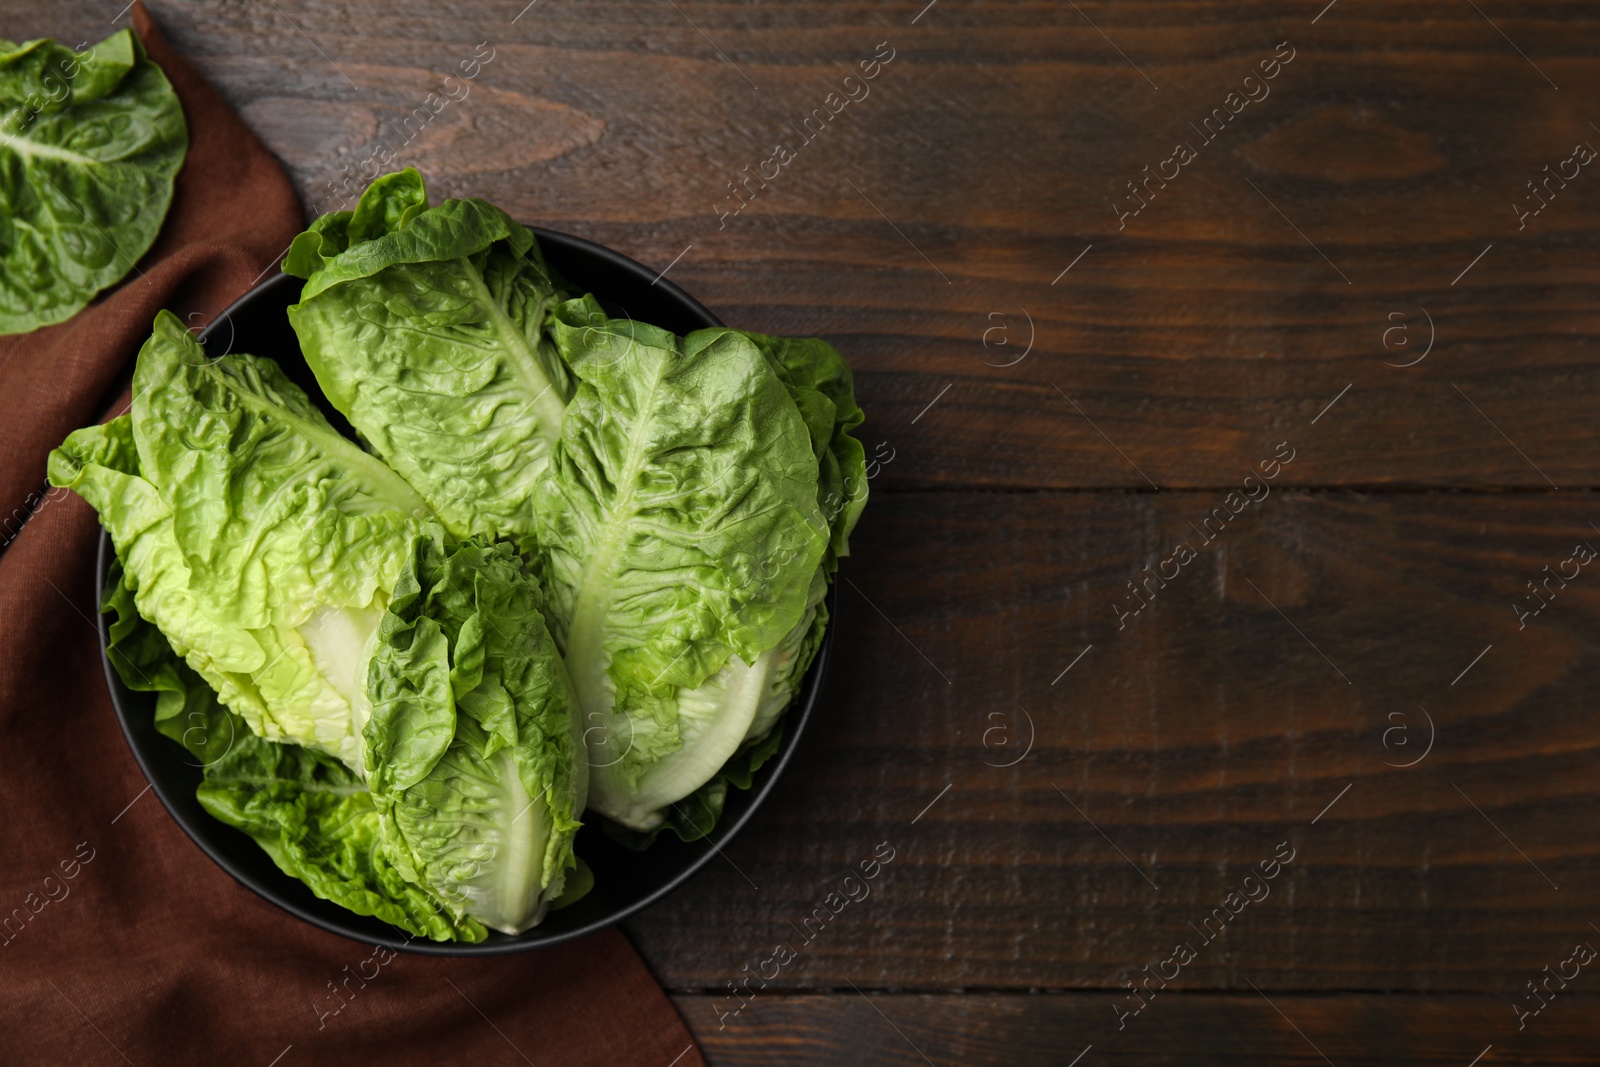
[{"left": 109, "top": 312, "right": 430, "bottom": 774}]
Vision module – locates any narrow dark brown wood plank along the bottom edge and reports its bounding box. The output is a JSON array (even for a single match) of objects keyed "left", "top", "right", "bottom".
[{"left": 677, "top": 987, "right": 1600, "bottom": 1067}]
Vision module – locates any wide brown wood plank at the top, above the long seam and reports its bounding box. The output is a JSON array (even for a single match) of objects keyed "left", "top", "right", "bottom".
[{"left": 15, "top": 0, "right": 1600, "bottom": 488}]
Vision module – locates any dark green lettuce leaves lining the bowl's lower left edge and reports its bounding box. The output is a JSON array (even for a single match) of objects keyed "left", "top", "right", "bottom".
[{"left": 101, "top": 547, "right": 473, "bottom": 941}]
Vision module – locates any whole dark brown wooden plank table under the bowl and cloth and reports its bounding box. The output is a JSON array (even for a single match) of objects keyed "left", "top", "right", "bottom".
[{"left": 15, "top": 0, "right": 1600, "bottom": 1067}]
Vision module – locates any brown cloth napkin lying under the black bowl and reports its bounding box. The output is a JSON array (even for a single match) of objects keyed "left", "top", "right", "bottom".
[{"left": 0, "top": 5, "right": 704, "bottom": 1067}]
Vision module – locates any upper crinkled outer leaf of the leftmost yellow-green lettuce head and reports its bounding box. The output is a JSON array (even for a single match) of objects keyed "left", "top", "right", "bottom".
[{"left": 133, "top": 312, "right": 430, "bottom": 639}]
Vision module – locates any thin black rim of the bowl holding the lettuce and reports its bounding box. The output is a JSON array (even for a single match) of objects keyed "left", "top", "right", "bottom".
[{"left": 94, "top": 226, "right": 838, "bottom": 957}]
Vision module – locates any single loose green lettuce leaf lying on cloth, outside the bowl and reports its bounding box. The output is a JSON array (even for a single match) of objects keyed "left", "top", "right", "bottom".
[{"left": 0, "top": 30, "right": 189, "bottom": 334}]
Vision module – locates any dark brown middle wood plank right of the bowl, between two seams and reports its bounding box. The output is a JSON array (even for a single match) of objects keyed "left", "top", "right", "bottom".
[{"left": 629, "top": 491, "right": 1600, "bottom": 995}]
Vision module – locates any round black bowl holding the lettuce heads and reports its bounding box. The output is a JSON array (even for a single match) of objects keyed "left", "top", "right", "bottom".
[{"left": 98, "top": 229, "right": 834, "bottom": 955}]
